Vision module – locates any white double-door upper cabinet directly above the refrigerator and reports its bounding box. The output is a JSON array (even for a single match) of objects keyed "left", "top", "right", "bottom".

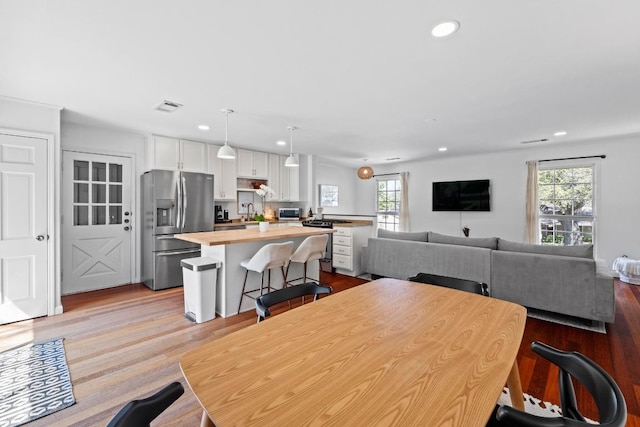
[{"left": 151, "top": 135, "right": 207, "bottom": 173}]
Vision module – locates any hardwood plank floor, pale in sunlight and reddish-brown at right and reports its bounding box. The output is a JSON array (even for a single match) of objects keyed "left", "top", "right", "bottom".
[{"left": 0, "top": 273, "right": 640, "bottom": 427}]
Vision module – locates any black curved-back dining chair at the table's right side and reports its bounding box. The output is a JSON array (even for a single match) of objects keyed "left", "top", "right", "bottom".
[{"left": 487, "top": 342, "right": 627, "bottom": 427}]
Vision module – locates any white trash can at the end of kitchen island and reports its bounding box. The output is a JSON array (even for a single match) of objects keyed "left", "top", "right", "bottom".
[{"left": 180, "top": 257, "right": 221, "bottom": 323}]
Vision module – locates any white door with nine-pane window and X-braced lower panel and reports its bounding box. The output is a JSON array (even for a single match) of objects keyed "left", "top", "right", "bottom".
[{"left": 62, "top": 151, "right": 133, "bottom": 294}]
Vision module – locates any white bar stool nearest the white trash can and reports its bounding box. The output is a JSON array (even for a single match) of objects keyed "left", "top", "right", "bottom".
[{"left": 238, "top": 242, "right": 293, "bottom": 314}]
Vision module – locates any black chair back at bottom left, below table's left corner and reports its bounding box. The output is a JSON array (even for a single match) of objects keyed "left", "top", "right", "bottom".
[{"left": 107, "top": 381, "right": 184, "bottom": 427}]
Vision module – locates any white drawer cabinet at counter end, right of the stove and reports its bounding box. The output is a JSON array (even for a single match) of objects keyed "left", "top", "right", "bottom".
[{"left": 332, "top": 225, "right": 371, "bottom": 277}]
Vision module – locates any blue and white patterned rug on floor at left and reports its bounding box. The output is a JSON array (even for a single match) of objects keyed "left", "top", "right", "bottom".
[{"left": 0, "top": 338, "right": 76, "bottom": 427}]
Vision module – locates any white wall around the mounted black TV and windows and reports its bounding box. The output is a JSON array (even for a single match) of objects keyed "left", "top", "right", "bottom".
[{"left": 351, "top": 135, "right": 640, "bottom": 266}]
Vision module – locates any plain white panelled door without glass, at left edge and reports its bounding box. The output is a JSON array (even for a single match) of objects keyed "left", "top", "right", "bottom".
[{"left": 0, "top": 133, "right": 49, "bottom": 324}]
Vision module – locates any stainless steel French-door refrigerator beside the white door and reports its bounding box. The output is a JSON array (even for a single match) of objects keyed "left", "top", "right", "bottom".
[{"left": 140, "top": 170, "right": 214, "bottom": 290}]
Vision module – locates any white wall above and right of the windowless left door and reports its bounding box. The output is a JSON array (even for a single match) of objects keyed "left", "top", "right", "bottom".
[{"left": 0, "top": 96, "right": 62, "bottom": 313}]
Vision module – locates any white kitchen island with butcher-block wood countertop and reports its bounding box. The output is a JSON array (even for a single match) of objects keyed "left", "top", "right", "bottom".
[{"left": 174, "top": 227, "right": 335, "bottom": 317}]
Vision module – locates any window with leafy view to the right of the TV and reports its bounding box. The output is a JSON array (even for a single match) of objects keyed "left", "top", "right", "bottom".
[{"left": 538, "top": 166, "right": 595, "bottom": 246}]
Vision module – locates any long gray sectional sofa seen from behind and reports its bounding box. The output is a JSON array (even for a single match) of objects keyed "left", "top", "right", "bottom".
[{"left": 362, "top": 230, "right": 615, "bottom": 322}]
